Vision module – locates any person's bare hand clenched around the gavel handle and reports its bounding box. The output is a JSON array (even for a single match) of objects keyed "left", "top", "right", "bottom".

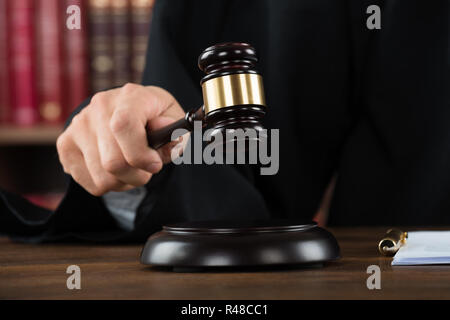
[{"left": 57, "top": 84, "right": 184, "bottom": 196}]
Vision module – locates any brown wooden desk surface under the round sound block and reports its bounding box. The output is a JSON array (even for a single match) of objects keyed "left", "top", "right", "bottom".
[{"left": 0, "top": 228, "right": 450, "bottom": 299}]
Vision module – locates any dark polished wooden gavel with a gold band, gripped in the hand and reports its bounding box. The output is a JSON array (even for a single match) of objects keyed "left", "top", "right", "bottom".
[{"left": 147, "top": 42, "right": 266, "bottom": 149}]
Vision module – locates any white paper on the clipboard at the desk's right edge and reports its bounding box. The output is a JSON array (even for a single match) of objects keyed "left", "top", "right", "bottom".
[{"left": 392, "top": 231, "right": 450, "bottom": 266}]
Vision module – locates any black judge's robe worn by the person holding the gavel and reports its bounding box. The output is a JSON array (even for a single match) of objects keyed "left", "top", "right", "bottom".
[{"left": 0, "top": 0, "right": 450, "bottom": 242}]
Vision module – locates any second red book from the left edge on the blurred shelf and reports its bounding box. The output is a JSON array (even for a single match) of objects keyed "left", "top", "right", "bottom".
[{"left": 8, "top": 0, "right": 38, "bottom": 126}]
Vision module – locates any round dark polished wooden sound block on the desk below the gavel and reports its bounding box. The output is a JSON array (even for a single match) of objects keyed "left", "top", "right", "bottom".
[{"left": 141, "top": 220, "right": 340, "bottom": 271}]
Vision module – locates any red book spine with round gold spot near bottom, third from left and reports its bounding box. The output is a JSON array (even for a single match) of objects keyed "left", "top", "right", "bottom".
[{"left": 35, "top": 0, "right": 64, "bottom": 124}]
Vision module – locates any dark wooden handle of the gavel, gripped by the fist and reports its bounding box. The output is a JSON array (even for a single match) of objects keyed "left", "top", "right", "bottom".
[{"left": 147, "top": 106, "right": 204, "bottom": 149}]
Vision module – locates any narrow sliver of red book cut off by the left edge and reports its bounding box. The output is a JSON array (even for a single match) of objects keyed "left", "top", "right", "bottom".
[{"left": 0, "top": 0, "right": 10, "bottom": 124}]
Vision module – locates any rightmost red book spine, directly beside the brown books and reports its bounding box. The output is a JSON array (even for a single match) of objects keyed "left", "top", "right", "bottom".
[{"left": 63, "top": 0, "right": 89, "bottom": 116}]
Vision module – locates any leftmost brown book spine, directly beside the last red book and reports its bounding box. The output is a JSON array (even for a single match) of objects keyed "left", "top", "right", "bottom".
[{"left": 88, "top": 0, "right": 114, "bottom": 93}]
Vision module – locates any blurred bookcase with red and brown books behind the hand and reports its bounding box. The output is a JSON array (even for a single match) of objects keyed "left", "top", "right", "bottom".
[{"left": 0, "top": 0, "right": 154, "bottom": 208}]
